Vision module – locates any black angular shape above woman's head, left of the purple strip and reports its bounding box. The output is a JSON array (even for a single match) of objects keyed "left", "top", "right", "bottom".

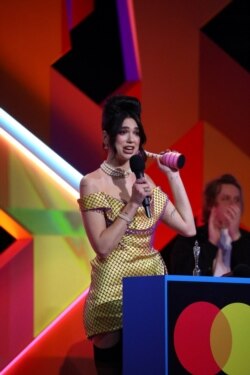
[{"left": 53, "top": 0, "right": 124, "bottom": 103}]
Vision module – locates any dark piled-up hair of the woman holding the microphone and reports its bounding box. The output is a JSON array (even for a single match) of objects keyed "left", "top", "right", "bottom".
[{"left": 102, "top": 94, "right": 147, "bottom": 153}]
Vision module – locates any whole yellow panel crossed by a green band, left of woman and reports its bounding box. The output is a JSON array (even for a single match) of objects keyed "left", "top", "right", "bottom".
[{"left": 0, "top": 119, "right": 94, "bottom": 336}]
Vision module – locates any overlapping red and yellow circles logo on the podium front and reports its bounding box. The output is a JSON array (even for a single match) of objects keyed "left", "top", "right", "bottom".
[{"left": 174, "top": 301, "right": 250, "bottom": 375}]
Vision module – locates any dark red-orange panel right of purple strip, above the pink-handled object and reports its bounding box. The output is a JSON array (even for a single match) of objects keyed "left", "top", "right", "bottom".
[{"left": 134, "top": 0, "right": 229, "bottom": 156}]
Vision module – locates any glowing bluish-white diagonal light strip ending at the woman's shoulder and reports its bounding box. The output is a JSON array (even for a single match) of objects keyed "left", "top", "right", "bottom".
[{"left": 0, "top": 108, "right": 82, "bottom": 190}]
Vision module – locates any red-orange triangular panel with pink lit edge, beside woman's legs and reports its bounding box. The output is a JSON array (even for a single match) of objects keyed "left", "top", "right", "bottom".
[{"left": 1, "top": 293, "right": 96, "bottom": 375}]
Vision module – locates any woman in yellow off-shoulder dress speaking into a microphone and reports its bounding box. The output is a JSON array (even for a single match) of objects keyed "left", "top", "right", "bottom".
[{"left": 78, "top": 95, "right": 195, "bottom": 374}]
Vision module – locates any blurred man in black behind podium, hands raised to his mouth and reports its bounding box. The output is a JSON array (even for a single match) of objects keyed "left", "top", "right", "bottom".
[{"left": 162, "top": 174, "right": 250, "bottom": 277}]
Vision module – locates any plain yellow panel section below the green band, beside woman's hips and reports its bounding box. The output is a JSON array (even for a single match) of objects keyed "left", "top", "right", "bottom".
[{"left": 34, "top": 236, "right": 93, "bottom": 336}]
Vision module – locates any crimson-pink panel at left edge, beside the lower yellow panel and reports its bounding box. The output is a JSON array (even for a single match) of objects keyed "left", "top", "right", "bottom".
[{"left": 0, "top": 239, "right": 33, "bottom": 370}]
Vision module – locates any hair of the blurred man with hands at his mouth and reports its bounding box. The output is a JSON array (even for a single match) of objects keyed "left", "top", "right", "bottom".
[{"left": 202, "top": 174, "right": 243, "bottom": 223}]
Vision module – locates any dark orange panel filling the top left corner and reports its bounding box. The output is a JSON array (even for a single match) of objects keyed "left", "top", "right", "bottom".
[{"left": 0, "top": 0, "right": 62, "bottom": 140}]
